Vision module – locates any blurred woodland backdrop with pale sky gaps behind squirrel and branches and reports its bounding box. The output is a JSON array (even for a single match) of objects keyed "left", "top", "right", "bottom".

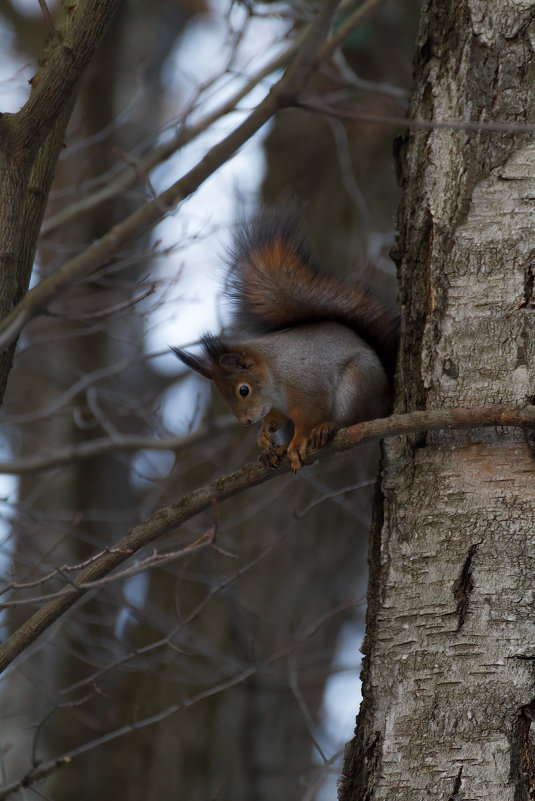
[{"left": 0, "top": 0, "right": 420, "bottom": 801}]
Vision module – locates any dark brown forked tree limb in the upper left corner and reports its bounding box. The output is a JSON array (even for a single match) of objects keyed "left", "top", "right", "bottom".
[{"left": 0, "top": 0, "right": 119, "bottom": 403}]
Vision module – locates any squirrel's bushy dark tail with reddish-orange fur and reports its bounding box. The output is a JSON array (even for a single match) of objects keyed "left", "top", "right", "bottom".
[{"left": 229, "top": 206, "right": 398, "bottom": 376}]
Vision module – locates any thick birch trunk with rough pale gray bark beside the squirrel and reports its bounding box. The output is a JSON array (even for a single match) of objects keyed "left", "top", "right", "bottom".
[{"left": 340, "top": 0, "right": 535, "bottom": 801}]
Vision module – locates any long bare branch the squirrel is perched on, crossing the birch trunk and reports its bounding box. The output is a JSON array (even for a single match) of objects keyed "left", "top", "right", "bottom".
[{"left": 0, "top": 405, "right": 535, "bottom": 672}]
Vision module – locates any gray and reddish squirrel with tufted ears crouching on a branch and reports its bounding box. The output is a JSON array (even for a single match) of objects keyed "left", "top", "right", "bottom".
[{"left": 171, "top": 207, "right": 398, "bottom": 472}]
